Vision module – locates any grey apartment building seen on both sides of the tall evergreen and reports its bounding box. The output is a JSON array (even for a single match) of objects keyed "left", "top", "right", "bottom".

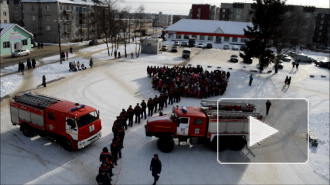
[{"left": 219, "top": 3, "right": 330, "bottom": 46}]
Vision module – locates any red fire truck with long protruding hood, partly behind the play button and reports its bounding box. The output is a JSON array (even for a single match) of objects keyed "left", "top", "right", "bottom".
[{"left": 145, "top": 100, "right": 262, "bottom": 152}]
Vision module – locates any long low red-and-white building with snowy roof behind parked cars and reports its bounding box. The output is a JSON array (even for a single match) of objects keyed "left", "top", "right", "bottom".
[{"left": 165, "top": 19, "right": 252, "bottom": 44}]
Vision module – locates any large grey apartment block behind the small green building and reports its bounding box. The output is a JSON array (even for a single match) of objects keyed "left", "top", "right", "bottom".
[{"left": 21, "top": 0, "right": 97, "bottom": 43}]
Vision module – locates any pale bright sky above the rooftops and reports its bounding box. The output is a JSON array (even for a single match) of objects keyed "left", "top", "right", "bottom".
[{"left": 121, "top": 0, "right": 329, "bottom": 15}]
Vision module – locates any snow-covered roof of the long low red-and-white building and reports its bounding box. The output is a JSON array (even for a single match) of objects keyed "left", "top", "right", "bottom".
[{"left": 165, "top": 19, "right": 252, "bottom": 35}]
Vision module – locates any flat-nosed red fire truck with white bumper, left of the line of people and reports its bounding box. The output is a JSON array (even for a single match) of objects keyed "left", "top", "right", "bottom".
[{"left": 10, "top": 93, "right": 102, "bottom": 151}]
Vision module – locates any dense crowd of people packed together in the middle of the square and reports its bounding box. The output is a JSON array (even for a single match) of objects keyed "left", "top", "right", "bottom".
[{"left": 147, "top": 65, "right": 230, "bottom": 98}]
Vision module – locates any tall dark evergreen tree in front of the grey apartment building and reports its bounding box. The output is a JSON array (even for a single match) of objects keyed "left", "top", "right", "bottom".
[{"left": 240, "top": 0, "right": 286, "bottom": 72}]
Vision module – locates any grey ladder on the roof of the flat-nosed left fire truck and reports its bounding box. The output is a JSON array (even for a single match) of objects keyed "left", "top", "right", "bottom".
[{"left": 14, "top": 93, "right": 61, "bottom": 108}]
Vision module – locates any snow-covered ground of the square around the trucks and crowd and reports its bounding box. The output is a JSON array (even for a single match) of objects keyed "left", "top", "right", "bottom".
[{"left": 1, "top": 41, "right": 330, "bottom": 184}]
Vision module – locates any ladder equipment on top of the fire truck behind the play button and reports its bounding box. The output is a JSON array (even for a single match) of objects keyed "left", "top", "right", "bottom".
[{"left": 201, "top": 100, "right": 256, "bottom": 112}]
